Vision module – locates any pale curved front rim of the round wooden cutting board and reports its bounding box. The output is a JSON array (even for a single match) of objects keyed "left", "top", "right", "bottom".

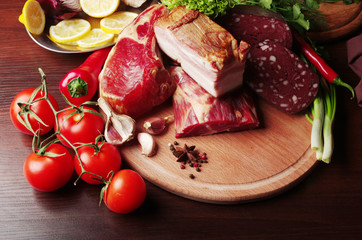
[{"left": 127, "top": 147, "right": 317, "bottom": 204}]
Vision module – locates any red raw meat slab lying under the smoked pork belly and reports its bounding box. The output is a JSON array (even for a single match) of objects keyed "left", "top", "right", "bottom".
[{"left": 170, "top": 67, "right": 259, "bottom": 138}]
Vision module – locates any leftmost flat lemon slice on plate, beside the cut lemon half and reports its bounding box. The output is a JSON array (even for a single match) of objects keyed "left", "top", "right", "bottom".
[{"left": 49, "top": 18, "right": 91, "bottom": 43}]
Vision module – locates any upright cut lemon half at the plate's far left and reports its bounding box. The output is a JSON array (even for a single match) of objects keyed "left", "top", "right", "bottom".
[{"left": 19, "top": 0, "right": 45, "bottom": 35}]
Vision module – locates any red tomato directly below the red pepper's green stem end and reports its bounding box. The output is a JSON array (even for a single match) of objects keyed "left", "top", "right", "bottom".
[{"left": 54, "top": 107, "right": 104, "bottom": 147}]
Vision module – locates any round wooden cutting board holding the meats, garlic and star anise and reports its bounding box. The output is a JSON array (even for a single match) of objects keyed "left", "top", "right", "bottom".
[{"left": 120, "top": 99, "right": 317, "bottom": 204}]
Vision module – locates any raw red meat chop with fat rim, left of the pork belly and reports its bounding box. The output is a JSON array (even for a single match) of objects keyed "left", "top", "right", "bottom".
[{"left": 99, "top": 4, "right": 176, "bottom": 118}]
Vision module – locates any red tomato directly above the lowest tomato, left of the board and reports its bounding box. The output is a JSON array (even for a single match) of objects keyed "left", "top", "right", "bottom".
[{"left": 74, "top": 142, "right": 122, "bottom": 184}]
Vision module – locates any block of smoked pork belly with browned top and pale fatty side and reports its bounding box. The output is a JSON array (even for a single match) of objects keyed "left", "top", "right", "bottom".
[{"left": 154, "top": 6, "right": 249, "bottom": 97}]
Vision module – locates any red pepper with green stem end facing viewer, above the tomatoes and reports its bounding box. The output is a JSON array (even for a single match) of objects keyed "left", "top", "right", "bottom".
[{"left": 59, "top": 47, "right": 111, "bottom": 106}]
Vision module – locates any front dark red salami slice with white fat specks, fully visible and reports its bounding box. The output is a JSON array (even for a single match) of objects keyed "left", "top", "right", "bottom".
[{"left": 245, "top": 40, "right": 319, "bottom": 114}]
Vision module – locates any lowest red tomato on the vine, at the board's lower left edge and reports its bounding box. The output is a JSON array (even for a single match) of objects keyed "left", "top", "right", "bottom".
[{"left": 103, "top": 169, "right": 146, "bottom": 213}]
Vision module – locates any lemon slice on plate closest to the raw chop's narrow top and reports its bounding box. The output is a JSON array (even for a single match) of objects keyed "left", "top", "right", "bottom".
[{"left": 100, "top": 11, "right": 138, "bottom": 34}]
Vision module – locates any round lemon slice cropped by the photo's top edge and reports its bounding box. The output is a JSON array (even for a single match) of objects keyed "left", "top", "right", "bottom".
[{"left": 80, "top": 0, "right": 120, "bottom": 18}]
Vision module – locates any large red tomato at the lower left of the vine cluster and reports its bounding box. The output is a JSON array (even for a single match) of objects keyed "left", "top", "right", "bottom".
[{"left": 23, "top": 143, "right": 73, "bottom": 192}]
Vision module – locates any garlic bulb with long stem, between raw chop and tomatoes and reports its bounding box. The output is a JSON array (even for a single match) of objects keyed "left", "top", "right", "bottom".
[{"left": 98, "top": 98, "right": 136, "bottom": 145}]
